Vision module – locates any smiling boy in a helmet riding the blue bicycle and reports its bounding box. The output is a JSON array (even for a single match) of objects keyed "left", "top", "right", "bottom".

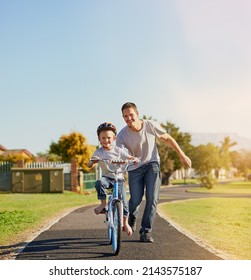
[{"left": 87, "top": 122, "right": 139, "bottom": 236}]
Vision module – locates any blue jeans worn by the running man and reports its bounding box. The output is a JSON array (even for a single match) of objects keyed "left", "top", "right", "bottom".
[{"left": 128, "top": 162, "right": 161, "bottom": 233}]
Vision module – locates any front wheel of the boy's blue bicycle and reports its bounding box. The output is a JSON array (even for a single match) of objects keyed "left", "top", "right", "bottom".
[{"left": 112, "top": 201, "right": 122, "bottom": 255}]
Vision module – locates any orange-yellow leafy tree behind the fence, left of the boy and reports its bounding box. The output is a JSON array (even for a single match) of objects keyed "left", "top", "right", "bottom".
[{"left": 49, "top": 132, "right": 90, "bottom": 171}]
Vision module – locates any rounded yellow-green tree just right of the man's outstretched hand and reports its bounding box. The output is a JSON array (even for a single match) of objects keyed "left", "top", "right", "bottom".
[{"left": 191, "top": 143, "right": 220, "bottom": 188}]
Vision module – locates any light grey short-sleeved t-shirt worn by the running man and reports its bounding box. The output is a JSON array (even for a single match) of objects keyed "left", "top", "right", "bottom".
[{"left": 116, "top": 120, "right": 166, "bottom": 170}]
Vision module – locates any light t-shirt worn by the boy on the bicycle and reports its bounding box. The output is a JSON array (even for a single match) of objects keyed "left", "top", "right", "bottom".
[{"left": 92, "top": 146, "right": 130, "bottom": 179}]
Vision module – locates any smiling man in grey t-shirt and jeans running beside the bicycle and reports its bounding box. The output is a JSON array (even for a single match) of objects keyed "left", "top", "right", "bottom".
[{"left": 116, "top": 102, "right": 191, "bottom": 242}]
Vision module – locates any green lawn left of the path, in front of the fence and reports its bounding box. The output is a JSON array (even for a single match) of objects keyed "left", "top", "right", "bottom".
[{"left": 0, "top": 192, "right": 97, "bottom": 245}]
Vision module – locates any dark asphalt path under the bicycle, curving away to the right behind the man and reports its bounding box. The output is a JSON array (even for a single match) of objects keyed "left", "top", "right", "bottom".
[{"left": 16, "top": 187, "right": 247, "bottom": 260}]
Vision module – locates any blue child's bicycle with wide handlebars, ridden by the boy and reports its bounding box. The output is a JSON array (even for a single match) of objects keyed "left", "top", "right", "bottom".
[{"left": 91, "top": 158, "right": 134, "bottom": 255}]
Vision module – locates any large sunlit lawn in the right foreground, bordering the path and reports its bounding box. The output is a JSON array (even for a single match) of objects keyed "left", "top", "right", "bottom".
[{"left": 159, "top": 198, "right": 251, "bottom": 260}]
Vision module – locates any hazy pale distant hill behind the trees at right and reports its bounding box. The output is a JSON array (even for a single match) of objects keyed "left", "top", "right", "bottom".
[{"left": 191, "top": 133, "right": 251, "bottom": 150}]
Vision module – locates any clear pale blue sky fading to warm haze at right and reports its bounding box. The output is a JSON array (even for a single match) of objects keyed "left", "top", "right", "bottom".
[{"left": 0, "top": 0, "right": 251, "bottom": 154}]
